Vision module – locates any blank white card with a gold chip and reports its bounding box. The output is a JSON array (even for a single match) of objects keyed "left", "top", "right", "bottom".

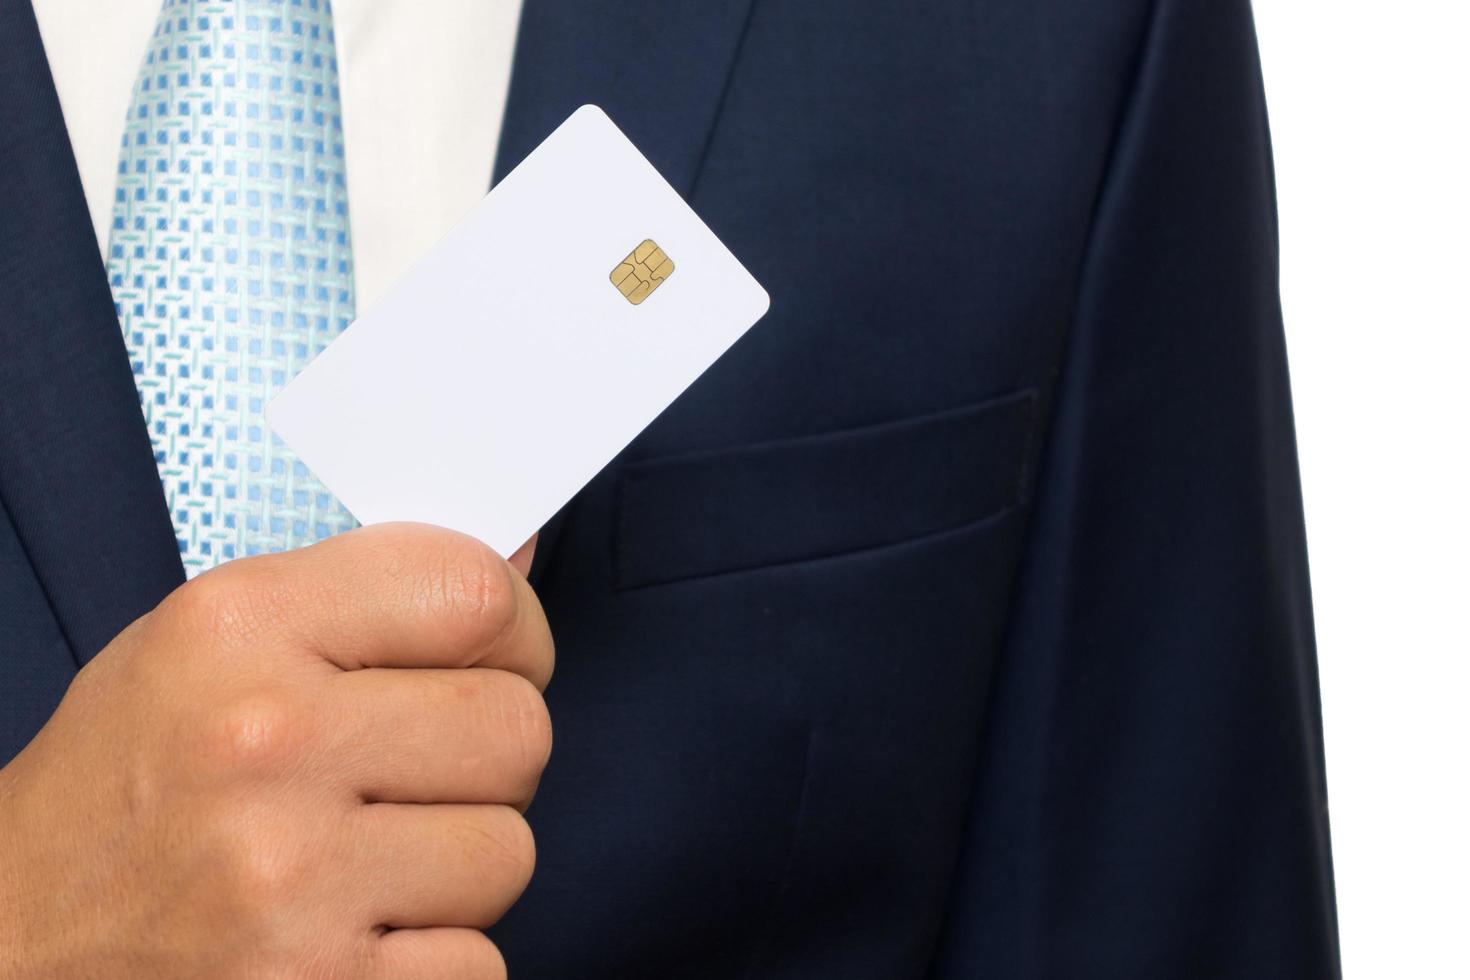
[{"left": 266, "top": 106, "right": 770, "bottom": 555}]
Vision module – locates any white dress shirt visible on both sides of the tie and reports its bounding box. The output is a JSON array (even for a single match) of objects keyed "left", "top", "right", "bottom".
[{"left": 32, "top": 0, "right": 522, "bottom": 311}]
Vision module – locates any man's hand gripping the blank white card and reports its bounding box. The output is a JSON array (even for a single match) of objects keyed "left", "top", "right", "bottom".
[{"left": 0, "top": 525, "right": 553, "bottom": 980}]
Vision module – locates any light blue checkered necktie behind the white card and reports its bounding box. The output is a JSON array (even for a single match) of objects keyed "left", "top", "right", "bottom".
[{"left": 107, "top": 0, "right": 354, "bottom": 577}]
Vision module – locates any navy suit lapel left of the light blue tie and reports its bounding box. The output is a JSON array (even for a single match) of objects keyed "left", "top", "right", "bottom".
[{"left": 0, "top": 0, "right": 184, "bottom": 664}]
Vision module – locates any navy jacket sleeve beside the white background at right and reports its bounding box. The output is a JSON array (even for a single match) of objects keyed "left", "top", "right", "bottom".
[{"left": 931, "top": 0, "right": 1339, "bottom": 980}]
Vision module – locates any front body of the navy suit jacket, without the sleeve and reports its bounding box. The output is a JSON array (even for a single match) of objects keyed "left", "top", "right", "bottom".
[{"left": 0, "top": 0, "right": 1136, "bottom": 979}]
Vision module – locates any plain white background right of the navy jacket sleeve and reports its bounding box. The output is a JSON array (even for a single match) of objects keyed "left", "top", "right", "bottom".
[{"left": 1255, "top": 0, "right": 1470, "bottom": 979}]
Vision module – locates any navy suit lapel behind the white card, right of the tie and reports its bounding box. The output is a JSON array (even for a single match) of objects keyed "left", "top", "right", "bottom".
[{"left": 495, "top": 0, "right": 753, "bottom": 585}]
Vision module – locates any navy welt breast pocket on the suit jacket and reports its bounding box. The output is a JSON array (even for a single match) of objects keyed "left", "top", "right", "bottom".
[{"left": 613, "top": 389, "right": 1036, "bottom": 589}]
